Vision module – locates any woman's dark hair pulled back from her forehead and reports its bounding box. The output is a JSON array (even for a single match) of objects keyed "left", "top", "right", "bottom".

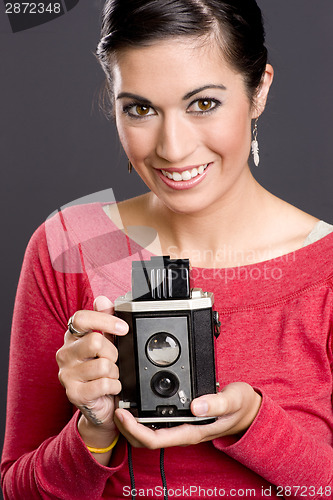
[{"left": 96, "top": 0, "right": 267, "bottom": 102}]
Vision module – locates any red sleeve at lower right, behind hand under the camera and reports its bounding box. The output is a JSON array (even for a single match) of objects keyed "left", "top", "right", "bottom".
[{"left": 213, "top": 390, "right": 333, "bottom": 499}]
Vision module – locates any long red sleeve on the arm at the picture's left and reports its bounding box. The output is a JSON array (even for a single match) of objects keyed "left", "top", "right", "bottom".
[{"left": 1, "top": 225, "right": 126, "bottom": 500}]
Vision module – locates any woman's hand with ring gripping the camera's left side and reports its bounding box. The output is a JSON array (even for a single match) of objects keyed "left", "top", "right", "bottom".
[{"left": 56, "top": 296, "right": 128, "bottom": 448}]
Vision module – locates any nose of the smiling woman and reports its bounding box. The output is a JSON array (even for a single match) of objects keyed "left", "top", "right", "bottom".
[{"left": 156, "top": 113, "right": 198, "bottom": 163}]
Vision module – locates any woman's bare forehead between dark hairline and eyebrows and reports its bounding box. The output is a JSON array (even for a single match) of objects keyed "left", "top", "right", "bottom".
[{"left": 112, "top": 37, "right": 245, "bottom": 98}]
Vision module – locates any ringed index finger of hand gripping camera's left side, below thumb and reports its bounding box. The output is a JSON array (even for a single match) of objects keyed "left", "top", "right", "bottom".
[{"left": 68, "top": 310, "right": 128, "bottom": 335}]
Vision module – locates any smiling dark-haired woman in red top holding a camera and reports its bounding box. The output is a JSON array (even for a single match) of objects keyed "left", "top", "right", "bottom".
[{"left": 2, "top": 0, "right": 333, "bottom": 499}]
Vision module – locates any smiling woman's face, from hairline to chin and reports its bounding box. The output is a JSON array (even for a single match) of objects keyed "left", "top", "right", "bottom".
[{"left": 113, "top": 38, "right": 262, "bottom": 213}]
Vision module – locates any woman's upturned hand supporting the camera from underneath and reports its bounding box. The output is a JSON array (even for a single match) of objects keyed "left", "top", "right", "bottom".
[{"left": 115, "top": 382, "right": 261, "bottom": 450}]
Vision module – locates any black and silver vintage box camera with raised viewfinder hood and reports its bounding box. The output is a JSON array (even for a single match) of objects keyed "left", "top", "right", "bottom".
[{"left": 114, "top": 257, "right": 220, "bottom": 427}]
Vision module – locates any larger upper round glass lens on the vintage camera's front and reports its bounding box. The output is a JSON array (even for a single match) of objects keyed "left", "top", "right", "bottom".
[{"left": 146, "top": 332, "right": 180, "bottom": 366}]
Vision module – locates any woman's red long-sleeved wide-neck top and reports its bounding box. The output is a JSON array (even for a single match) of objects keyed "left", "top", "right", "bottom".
[{"left": 2, "top": 204, "right": 333, "bottom": 500}]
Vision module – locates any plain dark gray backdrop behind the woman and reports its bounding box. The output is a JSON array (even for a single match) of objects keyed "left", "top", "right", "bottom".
[{"left": 0, "top": 0, "right": 333, "bottom": 492}]
